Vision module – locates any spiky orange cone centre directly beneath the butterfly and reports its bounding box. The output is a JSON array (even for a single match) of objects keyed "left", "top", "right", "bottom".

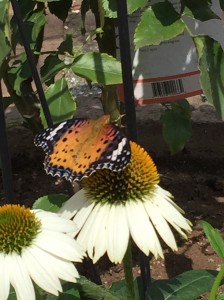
[{"left": 82, "top": 142, "right": 159, "bottom": 204}]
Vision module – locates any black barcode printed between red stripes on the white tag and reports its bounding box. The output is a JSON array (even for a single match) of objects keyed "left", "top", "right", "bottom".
[{"left": 151, "top": 79, "right": 184, "bottom": 97}]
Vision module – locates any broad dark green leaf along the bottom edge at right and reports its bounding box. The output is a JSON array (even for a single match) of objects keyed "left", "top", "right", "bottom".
[{"left": 146, "top": 270, "right": 218, "bottom": 300}]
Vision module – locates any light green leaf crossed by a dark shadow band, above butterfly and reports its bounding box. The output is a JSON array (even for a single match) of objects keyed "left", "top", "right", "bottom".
[{"left": 71, "top": 52, "right": 122, "bottom": 85}]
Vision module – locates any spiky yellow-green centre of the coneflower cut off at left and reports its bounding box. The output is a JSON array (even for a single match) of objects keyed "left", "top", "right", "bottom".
[{"left": 0, "top": 204, "right": 41, "bottom": 254}]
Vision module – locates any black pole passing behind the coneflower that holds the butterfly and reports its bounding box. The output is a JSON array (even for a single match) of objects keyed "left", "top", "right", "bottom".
[{"left": 117, "top": 0, "right": 151, "bottom": 300}]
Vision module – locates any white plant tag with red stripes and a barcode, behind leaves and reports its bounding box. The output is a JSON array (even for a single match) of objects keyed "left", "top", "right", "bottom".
[{"left": 118, "top": 0, "right": 224, "bottom": 104}]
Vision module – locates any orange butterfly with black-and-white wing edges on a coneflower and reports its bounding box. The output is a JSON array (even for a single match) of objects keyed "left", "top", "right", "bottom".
[{"left": 34, "top": 115, "right": 131, "bottom": 181}]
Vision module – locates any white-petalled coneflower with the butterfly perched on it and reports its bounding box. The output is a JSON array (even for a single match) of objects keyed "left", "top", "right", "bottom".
[{"left": 60, "top": 142, "right": 191, "bottom": 263}]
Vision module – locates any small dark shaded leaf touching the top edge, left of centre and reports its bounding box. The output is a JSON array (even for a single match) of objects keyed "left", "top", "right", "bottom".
[{"left": 48, "top": 0, "right": 72, "bottom": 22}]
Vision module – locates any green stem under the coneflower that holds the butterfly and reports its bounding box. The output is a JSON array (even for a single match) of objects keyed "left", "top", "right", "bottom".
[{"left": 123, "top": 242, "right": 135, "bottom": 300}]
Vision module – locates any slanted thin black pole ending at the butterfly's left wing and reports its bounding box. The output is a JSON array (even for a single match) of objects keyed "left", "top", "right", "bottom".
[{"left": 11, "top": 0, "right": 53, "bottom": 127}]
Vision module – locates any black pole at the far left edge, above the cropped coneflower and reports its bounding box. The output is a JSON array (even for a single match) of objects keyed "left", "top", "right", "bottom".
[{"left": 0, "top": 78, "right": 15, "bottom": 203}]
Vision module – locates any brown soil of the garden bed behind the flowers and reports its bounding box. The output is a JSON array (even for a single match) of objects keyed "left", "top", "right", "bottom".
[{"left": 1, "top": 95, "right": 224, "bottom": 299}]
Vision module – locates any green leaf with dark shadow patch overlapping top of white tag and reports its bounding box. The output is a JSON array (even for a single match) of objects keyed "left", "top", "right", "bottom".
[{"left": 134, "top": 1, "right": 185, "bottom": 48}]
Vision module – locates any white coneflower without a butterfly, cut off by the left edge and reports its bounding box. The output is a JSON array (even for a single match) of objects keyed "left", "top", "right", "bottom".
[{"left": 0, "top": 205, "right": 84, "bottom": 300}]
